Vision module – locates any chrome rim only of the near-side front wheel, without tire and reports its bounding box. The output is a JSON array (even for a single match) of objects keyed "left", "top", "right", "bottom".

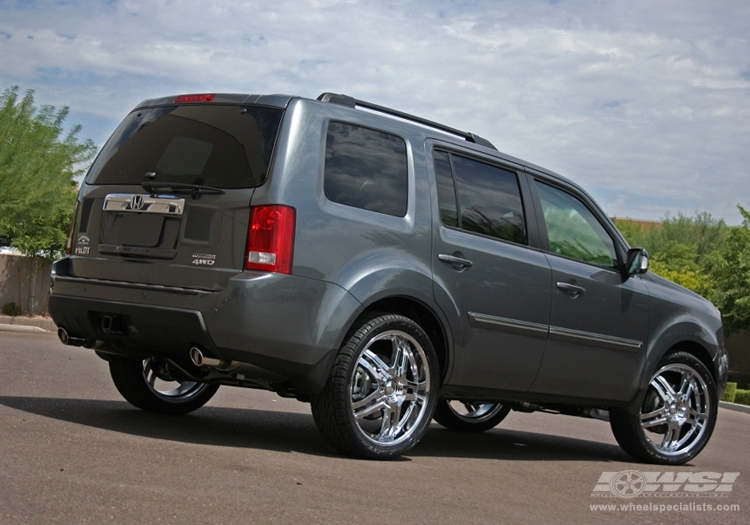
[{"left": 641, "top": 363, "right": 712, "bottom": 456}]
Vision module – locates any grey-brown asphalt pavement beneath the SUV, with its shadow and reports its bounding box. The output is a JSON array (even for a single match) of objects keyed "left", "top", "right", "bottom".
[{"left": 0, "top": 332, "right": 750, "bottom": 525}]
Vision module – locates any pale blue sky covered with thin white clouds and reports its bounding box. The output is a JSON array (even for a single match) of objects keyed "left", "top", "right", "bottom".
[{"left": 0, "top": 0, "right": 750, "bottom": 224}]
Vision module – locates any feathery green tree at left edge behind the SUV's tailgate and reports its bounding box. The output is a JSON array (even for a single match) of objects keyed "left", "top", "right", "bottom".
[{"left": 0, "top": 87, "right": 96, "bottom": 258}]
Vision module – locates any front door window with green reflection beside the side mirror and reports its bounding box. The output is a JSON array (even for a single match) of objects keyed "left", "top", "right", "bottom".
[{"left": 536, "top": 181, "right": 617, "bottom": 268}]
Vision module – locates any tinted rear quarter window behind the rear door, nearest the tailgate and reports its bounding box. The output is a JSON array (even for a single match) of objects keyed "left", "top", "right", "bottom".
[{"left": 323, "top": 122, "right": 408, "bottom": 217}]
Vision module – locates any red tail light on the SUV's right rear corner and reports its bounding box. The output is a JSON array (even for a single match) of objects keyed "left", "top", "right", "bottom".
[{"left": 245, "top": 205, "right": 296, "bottom": 273}]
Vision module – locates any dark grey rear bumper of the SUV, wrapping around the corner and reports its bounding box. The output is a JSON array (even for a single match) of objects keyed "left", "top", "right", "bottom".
[{"left": 49, "top": 260, "right": 362, "bottom": 394}]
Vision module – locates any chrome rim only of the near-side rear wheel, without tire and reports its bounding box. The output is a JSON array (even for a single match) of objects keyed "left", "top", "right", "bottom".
[{"left": 350, "top": 330, "right": 430, "bottom": 446}]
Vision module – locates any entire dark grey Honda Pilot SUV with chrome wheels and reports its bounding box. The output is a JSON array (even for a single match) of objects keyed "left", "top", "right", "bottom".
[{"left": 49, "top": 93, "right": 727, "bottom": 464}]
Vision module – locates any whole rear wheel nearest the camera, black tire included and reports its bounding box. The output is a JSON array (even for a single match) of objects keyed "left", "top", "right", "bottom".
[{"left": 311, "top": 314, "right": 439, "bottom": 459}]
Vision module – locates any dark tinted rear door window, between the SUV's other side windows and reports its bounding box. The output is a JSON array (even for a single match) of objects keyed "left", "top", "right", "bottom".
[{"left": 434, "top": 151, "right": 527, "bottom": 244}]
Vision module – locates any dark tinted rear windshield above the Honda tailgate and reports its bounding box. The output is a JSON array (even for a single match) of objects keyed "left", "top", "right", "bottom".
[{"left": 86, "top": 105, "right": 283, "bottom": 188}]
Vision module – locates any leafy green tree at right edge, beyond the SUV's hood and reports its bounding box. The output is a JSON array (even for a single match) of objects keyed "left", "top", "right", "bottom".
[{"left": 706, "top": 206, "right": 750, "bottom": 334}]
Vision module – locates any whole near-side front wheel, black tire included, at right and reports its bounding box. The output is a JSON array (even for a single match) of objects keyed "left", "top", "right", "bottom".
[{"left": 610, "top": 352, "right": 718, "bottom": 465}]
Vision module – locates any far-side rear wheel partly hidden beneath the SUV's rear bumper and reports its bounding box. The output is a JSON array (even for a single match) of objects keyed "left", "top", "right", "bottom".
[{"left": 109, "top": 358, "right": 219, "bottom": 415}]
